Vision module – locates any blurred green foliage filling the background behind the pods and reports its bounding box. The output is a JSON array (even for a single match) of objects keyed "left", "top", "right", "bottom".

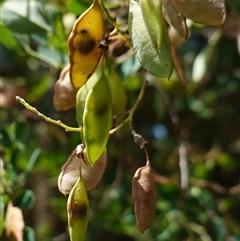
[{"left": 0, "top": 0, "right": 240, "bottom": 241}]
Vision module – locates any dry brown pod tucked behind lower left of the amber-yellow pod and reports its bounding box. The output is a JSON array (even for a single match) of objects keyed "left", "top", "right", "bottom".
[{"left": 53, "top": 65, "right": 77, "bottom": 111}]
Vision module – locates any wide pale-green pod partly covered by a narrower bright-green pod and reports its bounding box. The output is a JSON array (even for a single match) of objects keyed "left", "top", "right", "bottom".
[{"left": 129, "top": 0, "right": 173, "bottom": 78}]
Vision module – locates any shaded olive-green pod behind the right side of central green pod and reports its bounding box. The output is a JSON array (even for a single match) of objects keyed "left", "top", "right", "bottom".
[{"left": 108, "top": 68, "right": 127, "bottom": 124}]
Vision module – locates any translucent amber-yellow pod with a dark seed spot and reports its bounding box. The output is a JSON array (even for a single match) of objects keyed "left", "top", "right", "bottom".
[{"left": 68, "top": 0, "right": 104, "bottom": 88}]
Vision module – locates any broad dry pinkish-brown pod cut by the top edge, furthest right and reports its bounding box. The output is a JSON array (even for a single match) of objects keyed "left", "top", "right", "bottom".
[{"left": 168, "top": 0, "right": 226, "bottom": 26}]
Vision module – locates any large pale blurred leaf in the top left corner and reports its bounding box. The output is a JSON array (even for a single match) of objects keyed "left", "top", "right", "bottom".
[{"left": 1, "top": 0, "right": 51, "bottom": 33}]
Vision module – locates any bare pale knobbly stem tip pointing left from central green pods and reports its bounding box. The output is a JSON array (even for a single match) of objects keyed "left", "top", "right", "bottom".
[{"left": 16, "top": 96, "right": 82, "bottom": 132}]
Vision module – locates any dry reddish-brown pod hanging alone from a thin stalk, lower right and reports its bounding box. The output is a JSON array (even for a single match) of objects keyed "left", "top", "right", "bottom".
[{"left": 132, "top": 162, "right": 156, "bottom": 233}]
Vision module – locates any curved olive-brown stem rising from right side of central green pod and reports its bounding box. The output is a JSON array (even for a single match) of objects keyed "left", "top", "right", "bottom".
[{"left": 109, "top": 75, "right": 147, "bottom": 135}]
